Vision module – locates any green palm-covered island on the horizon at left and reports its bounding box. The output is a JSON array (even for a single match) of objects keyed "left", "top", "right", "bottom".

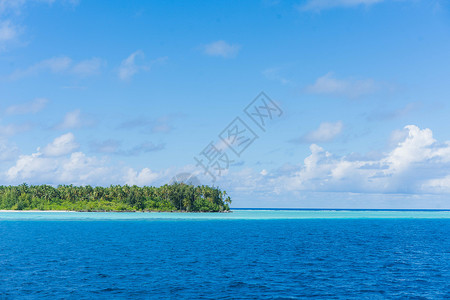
[{"left": 0, "top": 182, "right": 231, "bottom": 212}]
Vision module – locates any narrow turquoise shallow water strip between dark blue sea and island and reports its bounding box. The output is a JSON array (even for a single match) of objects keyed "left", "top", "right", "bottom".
[{"left": 0, "top": 209, "right": 450, "bottom": 220}]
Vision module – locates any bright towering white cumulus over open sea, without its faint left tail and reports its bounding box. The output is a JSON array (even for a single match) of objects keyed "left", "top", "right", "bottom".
[{"left": 274, "top": 125, "right": 450, "bottom": 193}]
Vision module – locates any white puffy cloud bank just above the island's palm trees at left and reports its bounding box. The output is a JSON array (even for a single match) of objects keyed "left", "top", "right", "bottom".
[{"left": 0, "top": 133, "right": 163, "bottom": 185}]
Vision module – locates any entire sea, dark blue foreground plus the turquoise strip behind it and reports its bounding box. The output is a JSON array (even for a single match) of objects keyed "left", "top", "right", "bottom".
[{"left": 0, "top": 211, "right": 450, "bottom": 299}]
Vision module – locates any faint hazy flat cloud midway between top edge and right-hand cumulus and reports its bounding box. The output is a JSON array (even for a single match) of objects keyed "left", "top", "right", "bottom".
[{"left": 306, "top": 72, "right": 378, "bottom": 98}]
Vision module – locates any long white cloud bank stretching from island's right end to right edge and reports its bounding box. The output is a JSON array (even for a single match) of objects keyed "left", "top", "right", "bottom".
[{"left": 208, "top": 125, "right": 450, "bottom": 198}]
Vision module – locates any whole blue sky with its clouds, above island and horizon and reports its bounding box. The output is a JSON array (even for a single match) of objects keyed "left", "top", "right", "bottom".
[{"left": 0, "top": 0, "right": 450, "bottom": 208}]
